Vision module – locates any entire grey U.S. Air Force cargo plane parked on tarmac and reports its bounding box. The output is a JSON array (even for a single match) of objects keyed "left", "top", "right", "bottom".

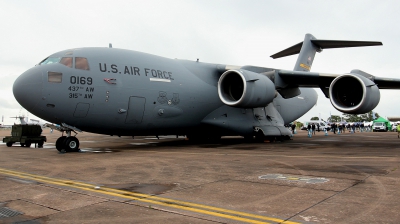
[{"left": 13, "top": 34, "right": 400, "bottom": 151}]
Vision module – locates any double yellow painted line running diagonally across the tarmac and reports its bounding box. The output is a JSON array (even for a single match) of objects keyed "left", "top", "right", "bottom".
[{"left": 0, "top": 168, "right": 299, "bottom": 224}]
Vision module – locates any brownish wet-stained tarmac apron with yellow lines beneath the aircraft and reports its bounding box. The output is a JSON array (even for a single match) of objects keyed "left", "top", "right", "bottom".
[{"left": 0, "top": 129, "right": 400, "bottom": 224}]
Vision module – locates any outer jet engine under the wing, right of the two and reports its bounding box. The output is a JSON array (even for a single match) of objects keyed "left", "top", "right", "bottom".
[{"left": 329, "top": 74, "right": 380, "bottom": 114}]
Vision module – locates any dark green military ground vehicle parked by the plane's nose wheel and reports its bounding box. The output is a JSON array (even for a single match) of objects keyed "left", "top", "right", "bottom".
[{"left": 3, "top": 124, "right": 47, "bottom": 148}]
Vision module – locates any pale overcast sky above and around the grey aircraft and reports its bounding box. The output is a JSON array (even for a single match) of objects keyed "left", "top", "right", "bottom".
[{"left": 0, "top": 0, "right": 400, "bottom": 124}]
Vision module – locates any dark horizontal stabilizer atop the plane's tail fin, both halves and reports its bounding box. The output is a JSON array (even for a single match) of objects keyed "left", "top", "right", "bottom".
[{"left": 271, "top": 39, "right": 382, "bottom": 59}]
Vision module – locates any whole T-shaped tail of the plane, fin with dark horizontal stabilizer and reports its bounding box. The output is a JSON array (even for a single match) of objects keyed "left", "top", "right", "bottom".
[{"left": 271, "top": 34, "right": 382, "bottom": 72}]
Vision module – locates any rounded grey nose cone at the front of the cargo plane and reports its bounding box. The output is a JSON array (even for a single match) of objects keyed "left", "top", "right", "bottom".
[{"left": 13, "top": 67, "right": 42, "bottom": 111}]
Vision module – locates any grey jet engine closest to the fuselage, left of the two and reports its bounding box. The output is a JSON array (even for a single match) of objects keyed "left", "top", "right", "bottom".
[{"left": 218, "top": 69, "right": 276, "bottom": 108}]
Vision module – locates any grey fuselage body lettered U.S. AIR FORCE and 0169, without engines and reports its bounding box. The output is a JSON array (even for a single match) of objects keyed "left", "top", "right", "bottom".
[{"left": 13, "top": 48, "right": 317, "bottom": 136}]
